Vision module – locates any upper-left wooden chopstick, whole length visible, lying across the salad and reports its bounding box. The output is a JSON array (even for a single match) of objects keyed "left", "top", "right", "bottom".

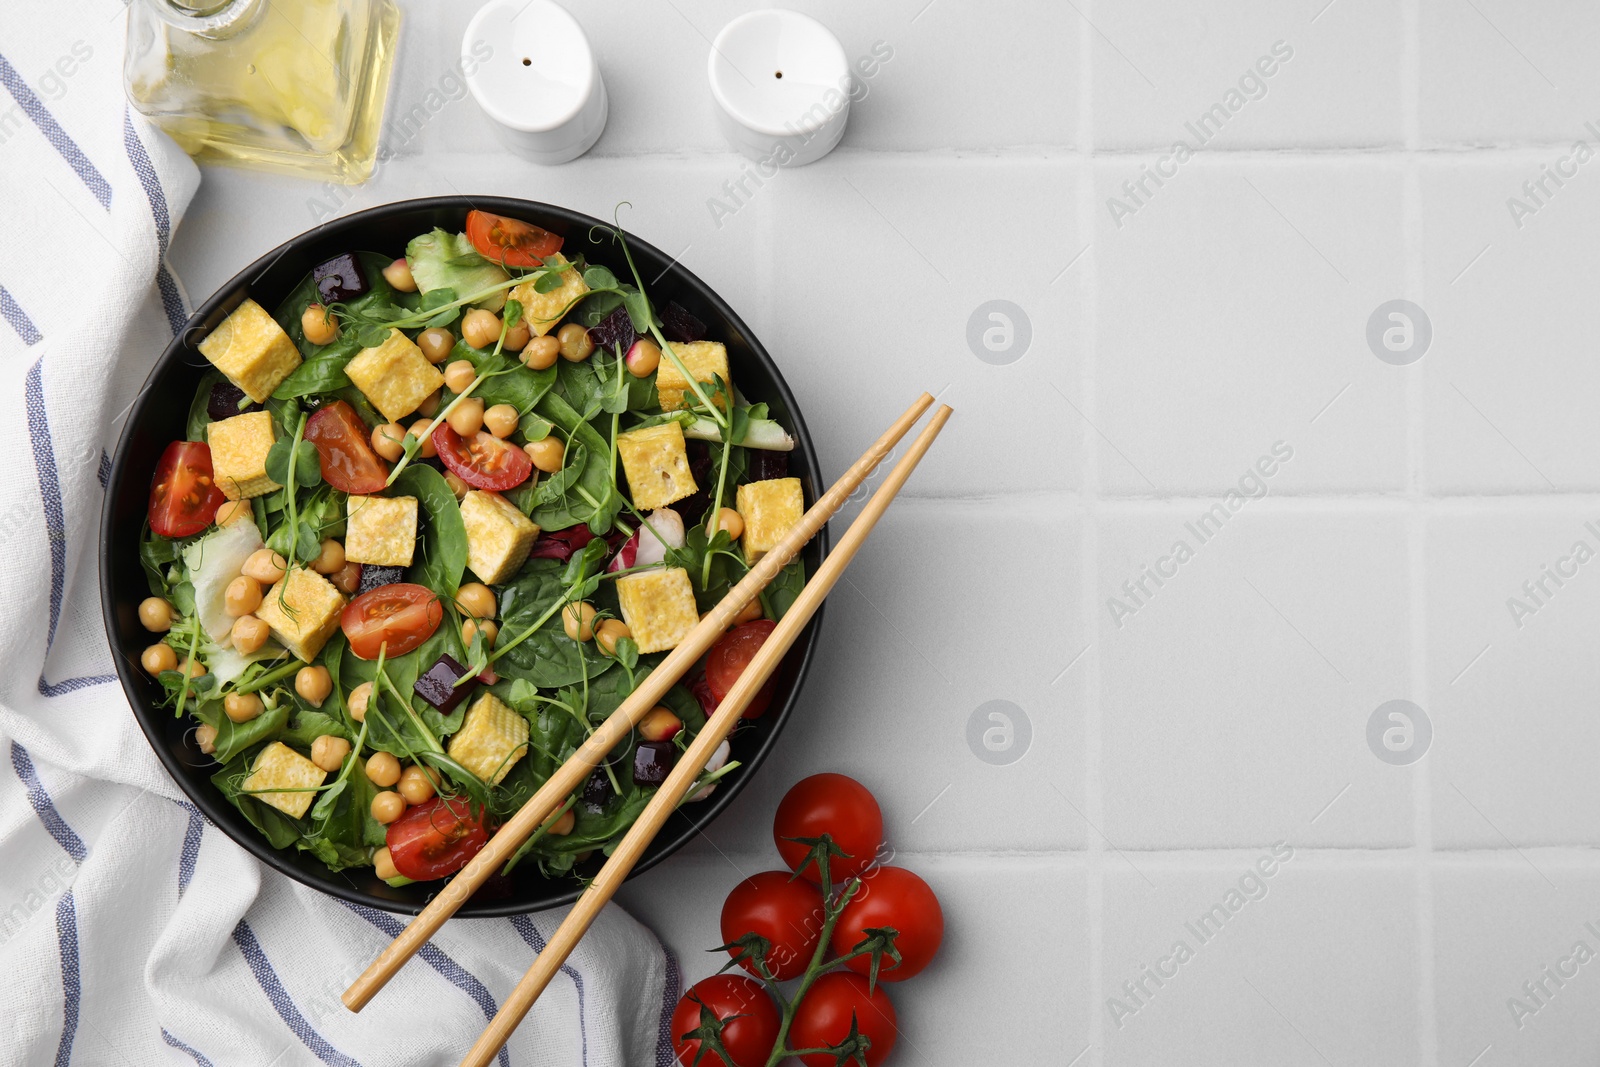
[{"left": 341, "top": 394, "right": 933, "bottom": 1017}]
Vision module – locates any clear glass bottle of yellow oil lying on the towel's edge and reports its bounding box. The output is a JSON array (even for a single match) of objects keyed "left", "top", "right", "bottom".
[{"left": 123, "top": 0, "right": 400, "bottom": 184}]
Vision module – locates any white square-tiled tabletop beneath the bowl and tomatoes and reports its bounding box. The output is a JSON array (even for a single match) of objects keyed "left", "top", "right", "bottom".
[{"left": 173, "top": 0, "right": 1600, "bottom": 1067}]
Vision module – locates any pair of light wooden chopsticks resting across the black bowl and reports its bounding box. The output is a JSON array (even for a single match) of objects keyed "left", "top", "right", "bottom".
[{"left": 342, "top": 394, "right": 950, "bottom": 1067}]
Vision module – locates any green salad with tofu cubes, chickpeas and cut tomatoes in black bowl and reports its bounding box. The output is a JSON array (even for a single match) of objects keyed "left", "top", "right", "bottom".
[{"left": 123, "top": 202, "right": 810, "bottom": 888}]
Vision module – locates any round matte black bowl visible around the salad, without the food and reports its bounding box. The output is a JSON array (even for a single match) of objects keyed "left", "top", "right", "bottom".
[{"left": 101, "top": 197, "right": 827, "bottom": 915}]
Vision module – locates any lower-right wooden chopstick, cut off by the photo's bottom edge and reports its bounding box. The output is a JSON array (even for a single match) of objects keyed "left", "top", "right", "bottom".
[{"left": 461, "top": 406, "right": 950, "bottom": 1067}]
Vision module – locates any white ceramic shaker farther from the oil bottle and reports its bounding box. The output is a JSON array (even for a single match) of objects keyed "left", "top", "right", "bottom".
[{"left": 707, "top": 8, "right": 850, "bottom": 166}]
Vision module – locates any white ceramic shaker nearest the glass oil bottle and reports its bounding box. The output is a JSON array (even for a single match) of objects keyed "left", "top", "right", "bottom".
[{"left": 461, "top": 0, "right": 606, "bottom": 163}]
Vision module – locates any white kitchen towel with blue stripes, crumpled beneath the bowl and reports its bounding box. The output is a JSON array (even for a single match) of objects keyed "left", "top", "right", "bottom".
[{"left": 0, "top": 8, "right": 678, "bottom": 1067}]
